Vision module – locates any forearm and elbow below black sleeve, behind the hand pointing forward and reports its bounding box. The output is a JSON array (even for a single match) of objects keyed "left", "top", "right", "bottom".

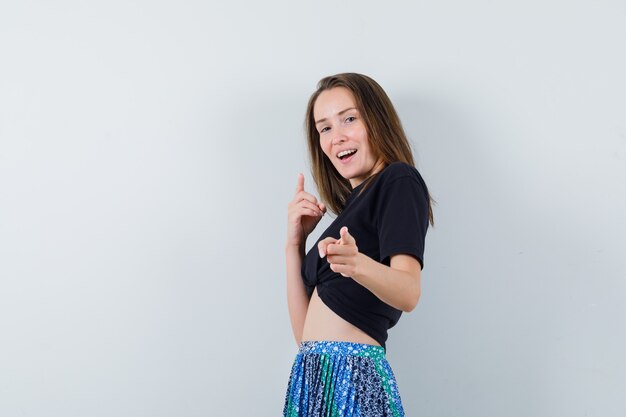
[{"left": 348, "top": 253, "right": 420, "bottom": 312}]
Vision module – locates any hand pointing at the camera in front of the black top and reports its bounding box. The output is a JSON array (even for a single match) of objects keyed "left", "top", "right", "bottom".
[{"left": 317, "top": 226, "right": 361, "bottom": 277}]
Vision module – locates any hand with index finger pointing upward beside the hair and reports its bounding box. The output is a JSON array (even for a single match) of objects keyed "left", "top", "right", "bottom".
[{"left": 287, "top": 174, "right": 326, "bottom": 246}]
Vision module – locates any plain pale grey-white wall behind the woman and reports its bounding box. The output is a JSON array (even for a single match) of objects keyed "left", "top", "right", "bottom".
[{"left": 0, "top": 0, "right": 626, "bottom": 417}]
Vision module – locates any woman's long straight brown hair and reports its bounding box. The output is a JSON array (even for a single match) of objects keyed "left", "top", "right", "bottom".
[{"left": 305, "top": 73, "right": 433, "bottom": 224}]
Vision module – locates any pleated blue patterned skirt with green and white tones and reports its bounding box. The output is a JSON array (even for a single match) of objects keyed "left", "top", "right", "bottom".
[{"left": 283, "top": 341, "right": 404, "bottom": 417}]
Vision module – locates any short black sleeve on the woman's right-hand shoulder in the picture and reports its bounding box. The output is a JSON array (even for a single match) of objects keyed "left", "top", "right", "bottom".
[{"left": 376, "top": 175, "right": 429, "bottom": 268}]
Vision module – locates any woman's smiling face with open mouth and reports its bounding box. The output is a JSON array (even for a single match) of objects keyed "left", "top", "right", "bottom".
[{"left": 313, "top": 87, "right": 383, "bottom": 188}]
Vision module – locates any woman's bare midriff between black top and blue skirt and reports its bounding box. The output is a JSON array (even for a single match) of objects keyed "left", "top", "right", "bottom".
[{"left": 302, "top": 287, "right": 380, "bottom": 346}]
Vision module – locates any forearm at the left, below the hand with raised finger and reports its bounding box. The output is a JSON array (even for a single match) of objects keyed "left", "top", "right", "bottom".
[{"left": 285, "top": 244, "right": 309, "bottom": 345}]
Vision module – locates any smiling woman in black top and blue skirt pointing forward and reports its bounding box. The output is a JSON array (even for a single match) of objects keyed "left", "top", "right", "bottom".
[{"left": 284, "top": 73, "right": 432, "bottom": 417}]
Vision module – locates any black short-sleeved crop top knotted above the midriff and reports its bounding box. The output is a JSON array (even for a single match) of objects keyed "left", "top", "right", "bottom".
[{"left": 301, "top": 162, "right": 429, "bottom": 347}]
